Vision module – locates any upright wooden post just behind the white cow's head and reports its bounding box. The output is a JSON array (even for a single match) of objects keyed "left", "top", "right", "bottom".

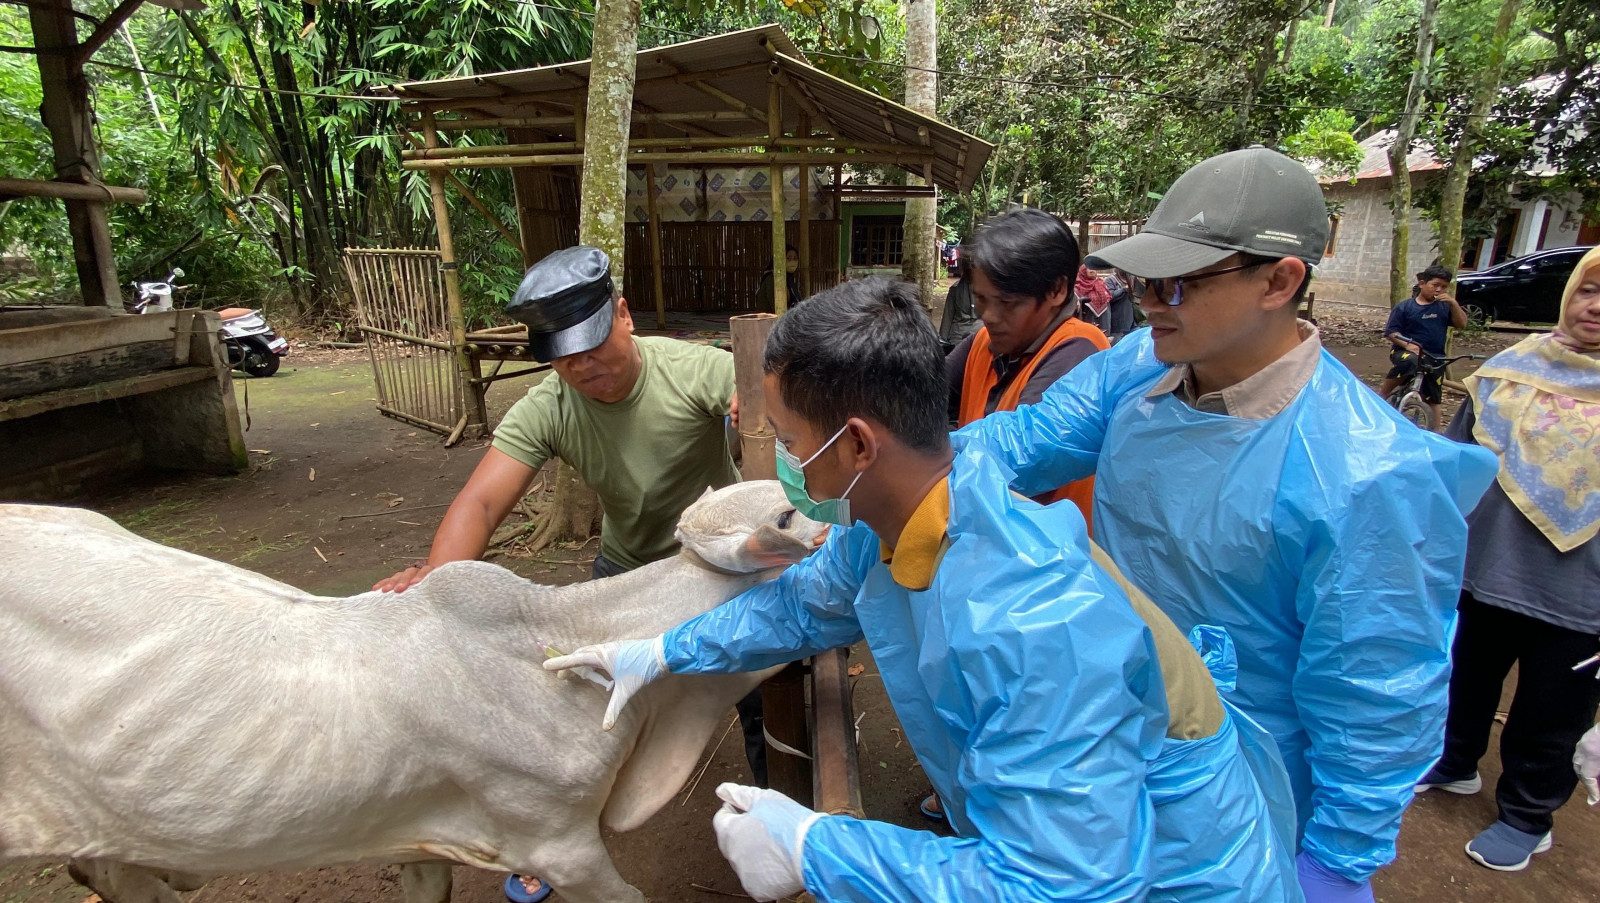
[{"left": 728, "top": 312, "right": 811, "bottom": 805}]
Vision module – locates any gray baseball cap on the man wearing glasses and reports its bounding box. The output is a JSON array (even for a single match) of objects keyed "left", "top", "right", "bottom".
[{"left": 1085, "top": 144, "right": 1328, "bottom": 279}]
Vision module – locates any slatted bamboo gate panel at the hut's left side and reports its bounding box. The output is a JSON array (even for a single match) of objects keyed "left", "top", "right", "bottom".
[{"left": 344, "top": 248, "right": 467, "bottom": 435}]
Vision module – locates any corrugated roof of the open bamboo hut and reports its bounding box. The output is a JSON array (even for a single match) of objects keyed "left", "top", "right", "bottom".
[{"left": 389, "top": 26, "right": 994, "bottom": 191}]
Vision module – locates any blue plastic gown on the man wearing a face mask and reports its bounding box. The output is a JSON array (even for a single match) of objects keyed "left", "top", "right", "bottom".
[{"left": 666, "top": 456, "right": 1301, "bottom": 903}]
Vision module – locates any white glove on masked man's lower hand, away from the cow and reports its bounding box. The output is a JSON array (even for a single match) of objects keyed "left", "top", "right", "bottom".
[{"left": 710, "top": 785, "right": 822, "bottom": 900}]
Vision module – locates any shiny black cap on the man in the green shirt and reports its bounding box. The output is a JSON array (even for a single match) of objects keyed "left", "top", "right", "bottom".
[{"left": 506, "top": 245, "right": 613, "bottom": 362}]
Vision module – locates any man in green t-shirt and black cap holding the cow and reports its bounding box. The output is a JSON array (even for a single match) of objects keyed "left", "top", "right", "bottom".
[{"left": 373, "top": 245, "right": 748, "bottom": 903}]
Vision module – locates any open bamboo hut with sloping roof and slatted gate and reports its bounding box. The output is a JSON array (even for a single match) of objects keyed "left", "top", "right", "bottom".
[{"left": 347, "top": 26, "right": 992, "bottom": 435}]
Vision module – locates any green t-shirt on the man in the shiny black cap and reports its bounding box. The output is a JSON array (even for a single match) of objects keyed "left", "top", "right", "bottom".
[{"left": 494, "top": 336, "right": 739, "bottom": 568}]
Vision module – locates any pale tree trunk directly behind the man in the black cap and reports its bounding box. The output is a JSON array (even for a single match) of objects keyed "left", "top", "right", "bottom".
[{"left": 530, "top": 0, "right": 643, "bottom": 551}]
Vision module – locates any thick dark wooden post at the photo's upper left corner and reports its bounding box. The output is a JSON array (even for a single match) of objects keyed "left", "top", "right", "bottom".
[{"left": 27, "top": 0, "right": 122, "bottom": 307}]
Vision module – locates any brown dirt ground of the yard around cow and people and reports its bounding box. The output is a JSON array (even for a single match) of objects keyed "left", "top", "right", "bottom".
[{"left": 0, "top": 306, "right": 1600, "bottom": 903}]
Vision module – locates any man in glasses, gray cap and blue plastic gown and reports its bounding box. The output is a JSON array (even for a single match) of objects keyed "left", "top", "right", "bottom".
[{"left": 955, "top": 147, "right": 1494, "bottom": 903}]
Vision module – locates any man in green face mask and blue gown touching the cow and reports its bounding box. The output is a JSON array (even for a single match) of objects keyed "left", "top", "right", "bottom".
[{"left": 546, "top": 279, "right": 1299, "bottom": 903}]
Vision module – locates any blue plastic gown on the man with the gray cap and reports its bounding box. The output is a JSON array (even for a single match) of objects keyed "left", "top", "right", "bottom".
[{"left": 954, "top": 330, "right": 1496, "bottom": 881}]
